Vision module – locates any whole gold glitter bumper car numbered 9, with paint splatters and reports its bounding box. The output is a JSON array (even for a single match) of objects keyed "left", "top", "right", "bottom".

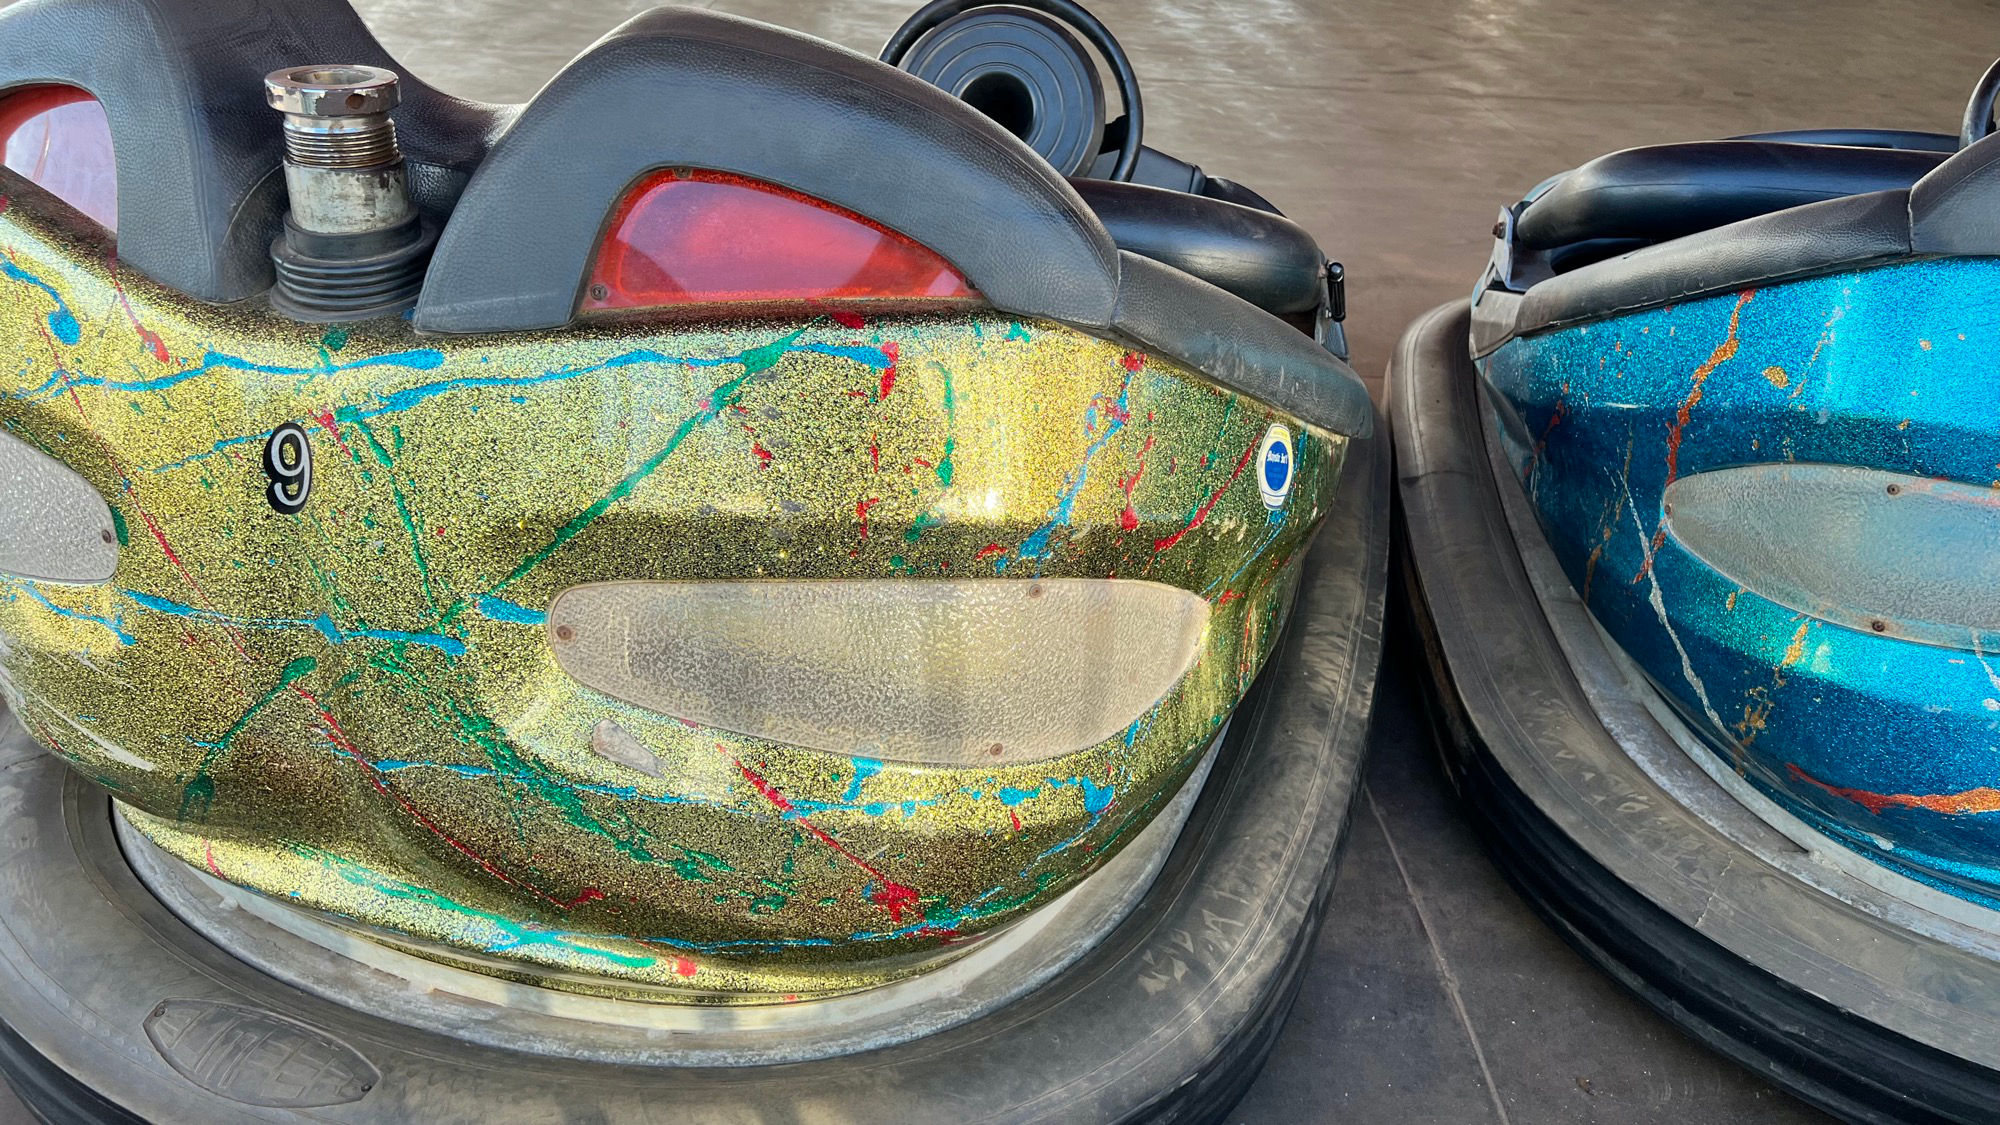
[{"left": 0, "top": 0, "right": 1386, "bottom": 1123}]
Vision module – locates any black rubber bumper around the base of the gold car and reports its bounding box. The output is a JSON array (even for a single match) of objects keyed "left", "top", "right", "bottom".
[{"left": 0, "top": 422, "right": 1390, "bottom": 1125}]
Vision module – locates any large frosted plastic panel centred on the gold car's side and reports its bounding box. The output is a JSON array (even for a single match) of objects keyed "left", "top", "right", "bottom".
[{"left": 548, "top": 579, "right": 1208, "bottom": 767}]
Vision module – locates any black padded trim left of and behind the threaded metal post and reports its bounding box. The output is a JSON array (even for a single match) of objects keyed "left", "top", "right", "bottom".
[{"left": 0, "top": 0, "right": 500, "bottom": 300}]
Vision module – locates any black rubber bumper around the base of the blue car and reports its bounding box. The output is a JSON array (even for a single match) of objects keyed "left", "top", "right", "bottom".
[{"left": 1390, "top": 304, "right": 2000, "bottom": 1123}]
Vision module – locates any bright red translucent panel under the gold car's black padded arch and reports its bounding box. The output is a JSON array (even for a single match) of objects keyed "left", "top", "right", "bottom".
[{"left": 584, "top": 170, "right": 978, "bottom": 308}]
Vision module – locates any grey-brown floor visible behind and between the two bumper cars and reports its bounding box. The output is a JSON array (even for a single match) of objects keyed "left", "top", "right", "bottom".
[{"left": 0, "top": 0, "right": 2000, "bottom": 1125}]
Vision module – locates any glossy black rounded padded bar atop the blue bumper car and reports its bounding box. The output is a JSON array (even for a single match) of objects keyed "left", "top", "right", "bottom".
[{"left": 1514, "top": 140, "right": 1946, "bottom": 250}]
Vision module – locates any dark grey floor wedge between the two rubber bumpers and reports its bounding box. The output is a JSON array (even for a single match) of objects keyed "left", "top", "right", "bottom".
[{"left": 1230, "top": 641, "right": 1828, "bottom": 1125}]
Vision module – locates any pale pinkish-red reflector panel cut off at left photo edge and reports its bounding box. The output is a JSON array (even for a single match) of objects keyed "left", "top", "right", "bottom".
[{"left": 0, "top": 86, "right": 118, "bottom": 230}]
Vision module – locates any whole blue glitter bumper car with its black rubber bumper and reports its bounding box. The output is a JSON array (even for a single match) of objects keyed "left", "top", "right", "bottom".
[{"left": 1390, "top": 66, "right": 2000, "bottom": 1121}]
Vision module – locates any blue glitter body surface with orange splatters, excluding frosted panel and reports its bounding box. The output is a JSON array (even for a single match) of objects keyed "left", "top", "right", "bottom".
[{"left": 1480, "top": 258, "right": 2000, "bottom": 907}]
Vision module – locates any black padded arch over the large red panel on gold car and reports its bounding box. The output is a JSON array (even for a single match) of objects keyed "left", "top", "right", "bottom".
[{"left": 416, "top": 8, "right": 1118, "bottom": 332}]
